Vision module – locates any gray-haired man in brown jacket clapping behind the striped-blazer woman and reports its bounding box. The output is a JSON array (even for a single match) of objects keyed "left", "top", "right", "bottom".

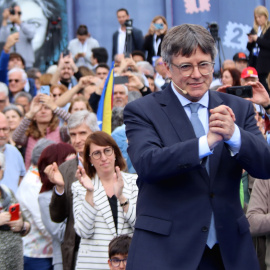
[{"left": 45, "top": 111, "right": 99, "bottom": 270}]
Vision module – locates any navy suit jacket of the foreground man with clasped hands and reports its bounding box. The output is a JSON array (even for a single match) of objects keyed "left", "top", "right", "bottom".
[{"left": 124, "top": 85, "right": 270, "bottom": 270}]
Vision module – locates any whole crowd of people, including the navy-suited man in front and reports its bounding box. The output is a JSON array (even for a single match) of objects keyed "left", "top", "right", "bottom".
[{"left": 0, "top": 3, "right": 270, "bottom": 270}]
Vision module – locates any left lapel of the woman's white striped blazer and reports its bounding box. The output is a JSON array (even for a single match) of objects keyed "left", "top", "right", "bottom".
[{"left": 93, "top": 174, "right": 116, "bottom": 236}]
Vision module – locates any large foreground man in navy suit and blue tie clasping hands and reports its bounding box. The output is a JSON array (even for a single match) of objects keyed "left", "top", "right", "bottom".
[{"left": 124, "top": 24, "right": 270, "bottom": 270}]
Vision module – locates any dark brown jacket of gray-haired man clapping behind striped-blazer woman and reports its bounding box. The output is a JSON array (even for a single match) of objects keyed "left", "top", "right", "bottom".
[{"left": 50, "top": 157, "right": 78, "bottom": 270}]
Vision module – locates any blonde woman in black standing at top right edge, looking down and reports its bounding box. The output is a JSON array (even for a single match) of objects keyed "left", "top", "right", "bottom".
[{"left": 247, "top": 6, "right": 270, "bottom": 93}]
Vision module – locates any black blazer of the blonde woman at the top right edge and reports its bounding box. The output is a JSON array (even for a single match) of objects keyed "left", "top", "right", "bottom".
[{"left": 256, "top": 28, "right": 270, "bottom": 74}]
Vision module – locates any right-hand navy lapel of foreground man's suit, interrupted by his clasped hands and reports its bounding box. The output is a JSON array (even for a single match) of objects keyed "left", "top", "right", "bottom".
[{"left": 208, "top": 90, "right": 224, "bottom": 185}]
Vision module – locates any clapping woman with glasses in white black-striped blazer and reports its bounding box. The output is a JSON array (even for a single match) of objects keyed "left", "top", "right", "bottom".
[{"left": 72, "top": 131, "right": 138, "bottom": 270}]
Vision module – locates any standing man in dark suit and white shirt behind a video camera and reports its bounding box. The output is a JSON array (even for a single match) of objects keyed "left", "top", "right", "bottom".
[{"left": 112, "top": 8, "right": 144, "bottom": 59}]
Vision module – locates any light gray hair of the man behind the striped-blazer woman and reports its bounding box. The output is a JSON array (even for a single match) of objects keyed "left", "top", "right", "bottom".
[{"left": 67, "top": 110, "right": 100, "bottom": 132}]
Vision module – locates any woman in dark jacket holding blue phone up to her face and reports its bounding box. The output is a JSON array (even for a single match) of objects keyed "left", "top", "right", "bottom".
[{"left": 144, "top": 15, "right": 168, "bottom": 66}]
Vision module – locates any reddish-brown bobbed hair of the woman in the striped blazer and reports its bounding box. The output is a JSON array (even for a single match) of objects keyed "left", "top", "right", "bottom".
[{"left": 83, "top": 131, "right": 127, "bottom": 178}]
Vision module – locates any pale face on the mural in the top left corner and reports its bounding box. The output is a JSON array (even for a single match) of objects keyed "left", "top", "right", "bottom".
[{"left": 17, "top": 0, "right": 48, "bottom": 51}]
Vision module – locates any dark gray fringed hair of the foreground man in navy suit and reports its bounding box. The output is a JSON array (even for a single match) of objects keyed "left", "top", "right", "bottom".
[{"left": 161, "top": 24, "right": 217, "bottom": 65}]
